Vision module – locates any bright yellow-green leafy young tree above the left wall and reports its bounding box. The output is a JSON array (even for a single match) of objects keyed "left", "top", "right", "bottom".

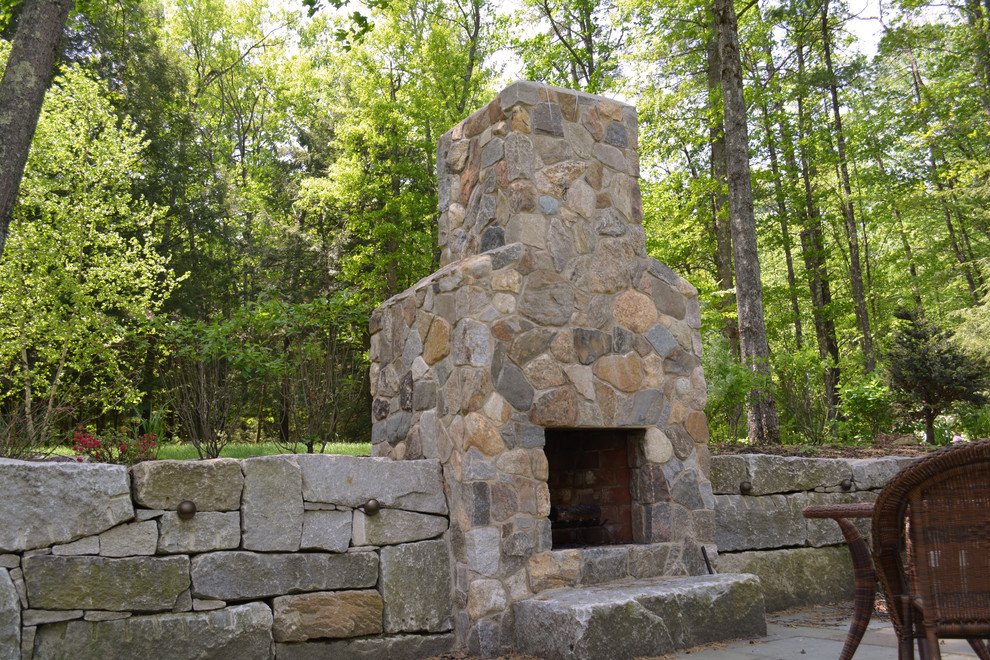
[{"left": 0, "top": 60, "right": 177, "bottom": 444}]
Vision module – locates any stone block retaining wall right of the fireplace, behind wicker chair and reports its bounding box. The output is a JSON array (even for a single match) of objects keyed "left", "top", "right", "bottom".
[{"left": 711, "top": 454, "right": 915, "bottom": 612}]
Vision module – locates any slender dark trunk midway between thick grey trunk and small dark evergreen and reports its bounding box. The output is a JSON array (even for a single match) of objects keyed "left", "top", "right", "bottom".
[{"left": 796, "top": 36, "right": 840, "bottom": 419}]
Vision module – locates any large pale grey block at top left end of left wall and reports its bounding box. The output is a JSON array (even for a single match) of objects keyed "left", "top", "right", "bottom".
[{"left": 0, "top": 458, "right": 134, "bottom": 552}]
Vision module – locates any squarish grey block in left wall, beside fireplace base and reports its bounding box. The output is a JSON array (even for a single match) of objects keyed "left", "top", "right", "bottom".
[{"left": 379, "top": 540, "right": 453, "bottom": 633}]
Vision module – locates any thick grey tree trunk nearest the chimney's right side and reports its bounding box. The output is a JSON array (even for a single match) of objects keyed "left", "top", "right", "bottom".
[{"left": 712, "top": 0, "right": 780, "bottom": 444}]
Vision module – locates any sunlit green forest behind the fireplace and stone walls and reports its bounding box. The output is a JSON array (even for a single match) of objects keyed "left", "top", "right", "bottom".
[{"left": 0, "top": 0, "right": 990, "bottom": 455}]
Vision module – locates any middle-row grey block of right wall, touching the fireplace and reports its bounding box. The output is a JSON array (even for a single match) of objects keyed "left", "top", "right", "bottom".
[{"left": 715, "top": 493, "right": 808, "bottom": 552}]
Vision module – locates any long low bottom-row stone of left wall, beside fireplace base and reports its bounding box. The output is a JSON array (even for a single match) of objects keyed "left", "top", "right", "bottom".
[{"left": 275, "top": 633, "right": 455, "bottom": 660}]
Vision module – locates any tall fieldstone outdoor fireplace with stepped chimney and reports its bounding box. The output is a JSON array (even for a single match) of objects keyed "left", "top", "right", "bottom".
[{"left": 371, "top": 82, "right": 714, "bottom": 655}]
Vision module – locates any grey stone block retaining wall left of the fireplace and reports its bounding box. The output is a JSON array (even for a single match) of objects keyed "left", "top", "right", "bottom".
[{"left": 0, "top": 455, "right": 454, "bottom": 660}]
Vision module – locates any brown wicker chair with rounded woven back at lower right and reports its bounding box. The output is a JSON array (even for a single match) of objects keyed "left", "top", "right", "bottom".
[{"left": 873, "top": 440, "right": 990, "bottom": 660}]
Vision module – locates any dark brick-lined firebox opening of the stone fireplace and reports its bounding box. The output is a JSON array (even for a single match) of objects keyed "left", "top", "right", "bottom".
[{"left": 543, "top": 428, "right": 642, "bottom": 549}]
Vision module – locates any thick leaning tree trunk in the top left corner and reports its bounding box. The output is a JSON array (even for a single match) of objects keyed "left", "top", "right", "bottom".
[{"left": 0, "top": 0, "right": 75, "bottom": 258}]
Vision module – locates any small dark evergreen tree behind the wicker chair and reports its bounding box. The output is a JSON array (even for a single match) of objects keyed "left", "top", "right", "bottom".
[{"left": 887, "top": 311, "right": 990, "bottom": 443}]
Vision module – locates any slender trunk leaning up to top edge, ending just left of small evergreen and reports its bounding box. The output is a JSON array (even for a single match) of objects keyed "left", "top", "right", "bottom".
[{"left": 822, "top": 0, "right": 876, "bottom": 372}]
